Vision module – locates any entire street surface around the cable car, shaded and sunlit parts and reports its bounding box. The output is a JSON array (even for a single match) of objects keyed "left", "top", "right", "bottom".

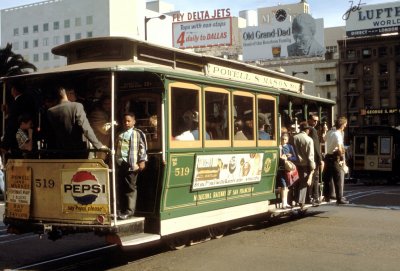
[{"left": 0, "top": 184, "right": 400, "bottom": 271}]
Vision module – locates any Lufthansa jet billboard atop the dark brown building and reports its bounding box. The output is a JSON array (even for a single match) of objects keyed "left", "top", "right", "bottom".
[{"left": 343, "top": 1, "right": 400, "bottom": 37}]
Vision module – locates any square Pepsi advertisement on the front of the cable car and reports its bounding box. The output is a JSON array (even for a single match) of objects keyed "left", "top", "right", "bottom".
[{"left": 61, "top": 169, "right": 109, "bottom": 214}]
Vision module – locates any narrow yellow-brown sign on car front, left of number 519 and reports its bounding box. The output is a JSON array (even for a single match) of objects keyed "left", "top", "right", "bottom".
[{"left": 6, "top": 167, "right": 32, "bottom": 219}]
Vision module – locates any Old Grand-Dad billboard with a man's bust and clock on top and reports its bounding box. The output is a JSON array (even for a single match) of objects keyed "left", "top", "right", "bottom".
[{"left": 242, "top": 10, "right": 325, "bottom": 61}]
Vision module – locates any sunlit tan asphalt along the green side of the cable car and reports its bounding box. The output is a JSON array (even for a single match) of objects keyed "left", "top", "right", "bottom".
[{"left": 111, "top": 204, "right": 400, "bottom": 271}]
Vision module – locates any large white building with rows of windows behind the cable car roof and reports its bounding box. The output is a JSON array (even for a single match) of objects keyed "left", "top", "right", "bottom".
[{"left": 1, "top": 0, "right": 172, "bottom": 70}]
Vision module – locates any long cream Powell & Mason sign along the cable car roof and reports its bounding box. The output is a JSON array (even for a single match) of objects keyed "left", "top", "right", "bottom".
[{"left": 206, "top": 64, "right": 301, "bottom": 93}]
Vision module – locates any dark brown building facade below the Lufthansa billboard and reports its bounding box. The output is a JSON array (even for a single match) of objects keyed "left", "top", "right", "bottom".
[{"left": 338, "top": 34, "right": 400, "bottom": 134}]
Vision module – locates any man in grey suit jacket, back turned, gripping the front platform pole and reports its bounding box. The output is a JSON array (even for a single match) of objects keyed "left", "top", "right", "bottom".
[{"left": 47, "top": 87, "right": 107, "bottom": 158}]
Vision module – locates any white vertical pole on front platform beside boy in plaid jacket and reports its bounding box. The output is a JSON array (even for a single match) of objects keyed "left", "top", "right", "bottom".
[{"left": 111, "top": 72, "right": 117, "bottom": 223}]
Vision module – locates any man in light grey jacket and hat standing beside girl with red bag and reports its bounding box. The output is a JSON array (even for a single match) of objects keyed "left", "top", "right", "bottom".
[{"left": 293, "top": 122, "right": 315, "bottom": 208}]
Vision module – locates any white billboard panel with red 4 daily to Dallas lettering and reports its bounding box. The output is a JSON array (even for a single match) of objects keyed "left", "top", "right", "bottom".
[{"left": 172, "top": 17, "right": 232, "bottom": 49}]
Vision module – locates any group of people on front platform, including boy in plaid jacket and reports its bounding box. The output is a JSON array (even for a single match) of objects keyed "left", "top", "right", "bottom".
[{"left": 1, "top": 84, "right": 147, "bottom": 219}]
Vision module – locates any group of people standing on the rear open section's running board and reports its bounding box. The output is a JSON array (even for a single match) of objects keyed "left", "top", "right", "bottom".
[{"left": 277, "top": 115, "right": 348, "bottom": 209}]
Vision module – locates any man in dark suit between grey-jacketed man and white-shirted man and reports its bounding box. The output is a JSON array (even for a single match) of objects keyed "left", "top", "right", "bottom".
[{"left": 308, "top": 114, "right": 324, "bottom": 206}]
